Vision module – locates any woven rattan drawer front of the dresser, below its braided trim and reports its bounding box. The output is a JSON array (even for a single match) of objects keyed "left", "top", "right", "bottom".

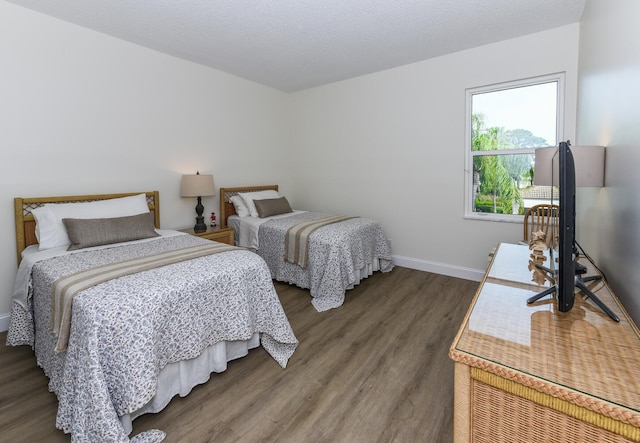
[{"left": 471, "top": 380, "right": 633, "bottom": 443}]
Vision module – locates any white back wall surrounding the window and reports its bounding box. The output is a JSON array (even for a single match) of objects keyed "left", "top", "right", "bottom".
[{"left": 291, "top": 24, "right": 579, "bottom": 278}]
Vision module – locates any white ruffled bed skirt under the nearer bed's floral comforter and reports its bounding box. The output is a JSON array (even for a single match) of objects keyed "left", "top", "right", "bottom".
[{"left": 120, "top": 333, "right": 260, "bottom": 434}]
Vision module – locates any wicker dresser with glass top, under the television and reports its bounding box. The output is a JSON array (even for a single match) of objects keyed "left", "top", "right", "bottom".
[{"left": 450, "top": 244, "right": 640, "bottom": 443}]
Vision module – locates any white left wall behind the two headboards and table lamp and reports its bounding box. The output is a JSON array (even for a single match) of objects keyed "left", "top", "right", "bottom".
[{"left": 0, "top": 1, "right": 289, "bottom": 330}]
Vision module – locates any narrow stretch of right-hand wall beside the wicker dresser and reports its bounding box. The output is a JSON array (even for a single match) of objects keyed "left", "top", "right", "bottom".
[{"left": 576, "top": 0, "right": 640, "bottom": 323}]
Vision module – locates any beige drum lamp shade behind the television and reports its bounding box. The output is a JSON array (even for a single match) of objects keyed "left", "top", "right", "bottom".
[{"left": 533, "top": 146, "right": 605, "bottom": 187}]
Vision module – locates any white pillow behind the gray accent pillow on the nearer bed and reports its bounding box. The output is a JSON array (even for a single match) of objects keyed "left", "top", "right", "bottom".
[{"left": 31, "top": 194, "right": 149, "bottom": 250}]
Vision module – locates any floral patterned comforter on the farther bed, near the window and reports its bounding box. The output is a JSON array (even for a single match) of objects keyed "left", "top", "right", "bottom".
[{"left": 258, "top": 212, "right": 393, "bottom": 312}]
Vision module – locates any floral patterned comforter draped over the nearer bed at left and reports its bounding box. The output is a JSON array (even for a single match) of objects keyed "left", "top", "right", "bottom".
[{"left": 8, "top": 235, "right": 298, "bottom": 442}]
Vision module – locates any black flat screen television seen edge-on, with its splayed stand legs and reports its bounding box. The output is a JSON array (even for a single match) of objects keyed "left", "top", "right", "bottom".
[{"left": 527, "top": 141, "right": 620, "bottom": 321}]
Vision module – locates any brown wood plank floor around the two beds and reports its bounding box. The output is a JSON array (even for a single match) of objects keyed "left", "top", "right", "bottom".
[{"left": 0, "top": 267, "right": 478, "bottom": 443}]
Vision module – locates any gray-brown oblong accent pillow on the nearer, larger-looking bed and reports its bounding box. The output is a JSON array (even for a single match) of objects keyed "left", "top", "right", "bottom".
[{"left": 62, "top": 212, "right": 159, "bottom": 251}]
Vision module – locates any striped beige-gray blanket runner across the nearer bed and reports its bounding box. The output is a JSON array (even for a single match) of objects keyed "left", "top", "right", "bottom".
[{"left": 50, "top": 242, "right": 239, "bottom": 352}]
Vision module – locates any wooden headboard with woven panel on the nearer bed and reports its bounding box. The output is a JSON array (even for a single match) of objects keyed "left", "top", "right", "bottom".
[{"left": 13, "top": 191, "right": 160, "bottom": 264}]
